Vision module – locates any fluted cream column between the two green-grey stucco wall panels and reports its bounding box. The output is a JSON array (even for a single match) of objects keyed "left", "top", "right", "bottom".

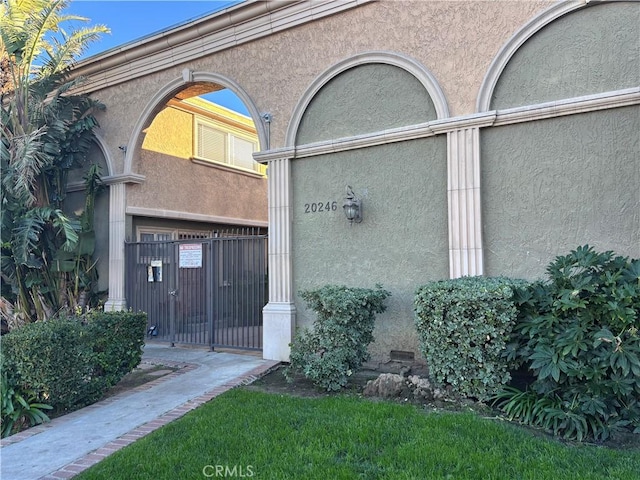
[{"left": 447, "top": 127, "right": 484, "bottom": 278}]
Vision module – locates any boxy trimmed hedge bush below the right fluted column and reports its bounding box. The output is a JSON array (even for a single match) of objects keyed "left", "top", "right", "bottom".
[{"left": 414, "top": 277, "right": 524, "bottom": 400}]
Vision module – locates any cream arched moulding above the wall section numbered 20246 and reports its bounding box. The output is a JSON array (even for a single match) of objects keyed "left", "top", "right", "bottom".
[{"left": 285, "top": 51, "right": 449, "bottom": 147}]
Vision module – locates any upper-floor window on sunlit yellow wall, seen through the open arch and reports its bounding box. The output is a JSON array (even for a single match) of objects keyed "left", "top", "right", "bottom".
[{"left": 194, "top": 118, "right": 266, "bottom": 175}]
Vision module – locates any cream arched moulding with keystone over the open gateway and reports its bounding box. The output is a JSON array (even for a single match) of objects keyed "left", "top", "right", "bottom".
[{"left": 124, "top": 69, "right": 269, "bottom": 175}]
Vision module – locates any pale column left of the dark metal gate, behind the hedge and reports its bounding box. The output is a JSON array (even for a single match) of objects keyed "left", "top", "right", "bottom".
[{"left": 104, "top": 183, "right": 127, "bottom": 311}]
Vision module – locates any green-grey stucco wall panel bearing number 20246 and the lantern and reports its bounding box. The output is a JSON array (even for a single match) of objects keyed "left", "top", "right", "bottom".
[{"left": 292, "top": 136, "right": 449, "bottom": 361}]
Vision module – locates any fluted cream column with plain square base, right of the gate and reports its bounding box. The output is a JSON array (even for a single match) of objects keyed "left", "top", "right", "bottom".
[{"left": 262, "top": 158, "right": 296, "bottom": 361}]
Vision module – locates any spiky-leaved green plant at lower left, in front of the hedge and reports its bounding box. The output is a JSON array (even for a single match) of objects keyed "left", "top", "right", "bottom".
[{"left": 0, "top": 372, "right": 52, "bottom": 438}]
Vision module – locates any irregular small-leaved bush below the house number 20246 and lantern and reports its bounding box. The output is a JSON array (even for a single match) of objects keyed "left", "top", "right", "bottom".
[{"left": 285, "top": 285, "right": 391, "bottom": 391}]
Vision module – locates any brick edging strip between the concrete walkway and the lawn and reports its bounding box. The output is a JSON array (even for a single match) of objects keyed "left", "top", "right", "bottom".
[{"left": 39, "top": 360, "right": 280, "bottom": 480}]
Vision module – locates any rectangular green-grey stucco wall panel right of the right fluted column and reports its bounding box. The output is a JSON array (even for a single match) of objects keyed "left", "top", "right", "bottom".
[{"left": 480, "top": 106, "right": 640, "bottom": 278}]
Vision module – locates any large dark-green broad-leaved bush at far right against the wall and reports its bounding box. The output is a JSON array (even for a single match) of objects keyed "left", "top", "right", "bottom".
[{"left": 499, "top": 245, "right": 640, "bottom": 440}]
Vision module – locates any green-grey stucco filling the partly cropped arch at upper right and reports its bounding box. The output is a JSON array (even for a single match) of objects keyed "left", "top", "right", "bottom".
[{"left": 491, "top": 2, "right": 640, "bottom": 109}]
